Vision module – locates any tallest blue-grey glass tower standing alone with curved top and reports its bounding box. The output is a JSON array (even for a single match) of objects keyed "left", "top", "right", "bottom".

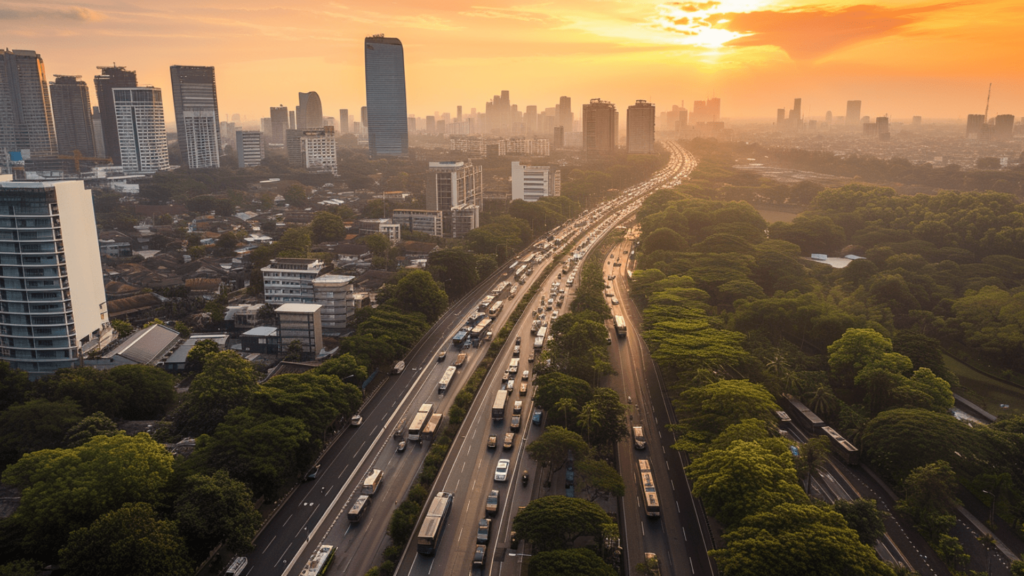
[{"left": 365, "top": 36, "right": 409, "bottom": 156}]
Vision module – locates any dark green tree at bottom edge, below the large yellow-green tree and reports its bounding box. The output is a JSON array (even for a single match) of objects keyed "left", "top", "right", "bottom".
[{"left": 60, "top": 502, "right": 194, "bottom": 576}]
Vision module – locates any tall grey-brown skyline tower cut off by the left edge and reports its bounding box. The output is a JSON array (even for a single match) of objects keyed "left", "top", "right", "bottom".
[{"left": 0, "top": 49, "right": 57, "bottom": 154}]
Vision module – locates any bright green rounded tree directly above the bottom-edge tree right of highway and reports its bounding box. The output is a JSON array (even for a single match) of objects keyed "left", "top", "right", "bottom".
[{"left": 686, "top": 441, "right": 808, "bottom": 528}]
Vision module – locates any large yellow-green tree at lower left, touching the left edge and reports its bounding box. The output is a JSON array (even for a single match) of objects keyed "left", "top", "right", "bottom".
[{"left": 3, "top": 433, "right": 174, "bottom": 558}]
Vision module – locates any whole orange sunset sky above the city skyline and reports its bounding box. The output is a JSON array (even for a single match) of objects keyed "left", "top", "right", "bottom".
[{"left": 8, "top": 0, "right": 1024, "bottom": 122}]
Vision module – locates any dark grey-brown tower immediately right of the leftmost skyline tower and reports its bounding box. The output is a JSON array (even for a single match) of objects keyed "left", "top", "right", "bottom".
[{"left": 50, "top": 76, "right": 96, "bottom": 156}]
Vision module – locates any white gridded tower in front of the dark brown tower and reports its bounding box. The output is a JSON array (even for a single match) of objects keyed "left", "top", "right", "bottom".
[{"left": 114, "top": 86, "right": 171, "bottom": 174}]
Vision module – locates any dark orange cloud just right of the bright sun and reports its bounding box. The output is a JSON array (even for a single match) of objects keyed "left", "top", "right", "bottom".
[{"left": 714, "top": 3, "right": 962, "bottom": 60}]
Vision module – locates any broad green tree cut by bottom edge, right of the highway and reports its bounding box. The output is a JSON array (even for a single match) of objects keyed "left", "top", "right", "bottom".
[{"left": 709, "top": 503, "right": 893, "bottom": 576}]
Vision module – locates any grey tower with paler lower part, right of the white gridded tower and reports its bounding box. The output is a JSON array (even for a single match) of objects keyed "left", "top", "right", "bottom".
[{"left": 171, "top": 66, "right": 220, "bottom": 170}]
